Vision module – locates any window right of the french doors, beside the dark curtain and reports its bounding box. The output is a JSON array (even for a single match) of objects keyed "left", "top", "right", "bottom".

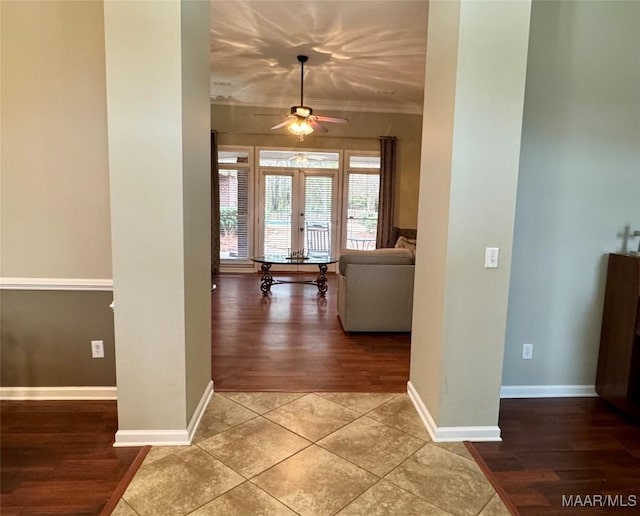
[{"left": 344, "top": 153, "right": 380, "bottom": 250}]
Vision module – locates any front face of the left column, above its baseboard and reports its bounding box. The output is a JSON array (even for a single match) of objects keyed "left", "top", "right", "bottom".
[{"left": 104, "top": 2, "right": 186, "bottom": 430}]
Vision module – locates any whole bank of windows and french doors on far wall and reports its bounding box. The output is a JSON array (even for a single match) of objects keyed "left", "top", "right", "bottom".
[{"left": 218, "top": 145, "right": 380, "bottom": 269}]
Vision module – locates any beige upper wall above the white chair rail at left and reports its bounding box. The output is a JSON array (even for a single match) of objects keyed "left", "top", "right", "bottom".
[{"left": 0, "top": 0, "right": 111, "bottom": 278}]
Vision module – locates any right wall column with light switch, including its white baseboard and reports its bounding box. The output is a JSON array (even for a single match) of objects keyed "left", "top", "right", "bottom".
[{"left": 409, "top": 0, "right": 531, "bottom": 440}]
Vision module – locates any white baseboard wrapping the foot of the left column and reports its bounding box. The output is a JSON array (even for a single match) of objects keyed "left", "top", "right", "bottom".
[{"left": 113, "top": 381, "right": 213, "bottom": 448}]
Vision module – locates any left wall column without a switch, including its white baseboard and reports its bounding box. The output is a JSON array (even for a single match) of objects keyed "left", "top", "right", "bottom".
[{"left": 104, "top": 1, "right": 211, "bottom": 445}]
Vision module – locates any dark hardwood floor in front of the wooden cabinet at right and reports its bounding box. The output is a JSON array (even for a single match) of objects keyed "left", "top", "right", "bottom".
[{"left": 464, "top": 398, "right": 640, "bottom": 516}]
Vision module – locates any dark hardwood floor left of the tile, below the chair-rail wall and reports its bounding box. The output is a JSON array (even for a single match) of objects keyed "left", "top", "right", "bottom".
[{"left": 0, "top": 401, "right": 142, "bottom": 516}]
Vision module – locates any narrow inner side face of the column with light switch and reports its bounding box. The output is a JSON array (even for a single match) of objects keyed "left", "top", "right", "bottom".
[{"left": 411, "top": 2, "right": 460, "bottom": 424}]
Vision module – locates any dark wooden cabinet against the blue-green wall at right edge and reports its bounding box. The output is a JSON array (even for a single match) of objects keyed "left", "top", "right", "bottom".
[{"left": 596, "top": 254, "right": 640, "bottom": 419}]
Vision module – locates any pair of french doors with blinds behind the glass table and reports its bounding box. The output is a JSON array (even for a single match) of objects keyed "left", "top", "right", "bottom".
[{"left": 257, "top": 168, "right": 338, "bottom": 269}]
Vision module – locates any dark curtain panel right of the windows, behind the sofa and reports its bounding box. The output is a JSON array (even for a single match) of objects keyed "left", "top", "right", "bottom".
[{"left": 376, "top": 136, "right": 397, "bottom": 249}]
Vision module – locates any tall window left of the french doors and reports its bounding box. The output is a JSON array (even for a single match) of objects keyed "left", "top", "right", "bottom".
[{"left": 218, "top": 146, "right": 252, "bottom": 262}]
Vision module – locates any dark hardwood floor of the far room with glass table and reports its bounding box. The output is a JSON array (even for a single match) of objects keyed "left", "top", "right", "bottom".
[{"left": 212, "top": 274, "right": 410, "bottom": 392}]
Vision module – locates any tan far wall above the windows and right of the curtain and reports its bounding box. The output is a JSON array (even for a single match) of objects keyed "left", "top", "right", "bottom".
[{"left": 211, "top": 104, "right": 422, "bottom": 228}]
